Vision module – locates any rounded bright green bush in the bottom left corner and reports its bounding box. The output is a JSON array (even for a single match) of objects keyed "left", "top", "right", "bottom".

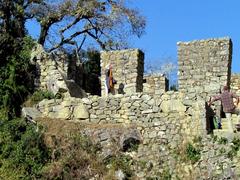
[{"left": 0, "top": 119, "right": 49, "bottom": 179}]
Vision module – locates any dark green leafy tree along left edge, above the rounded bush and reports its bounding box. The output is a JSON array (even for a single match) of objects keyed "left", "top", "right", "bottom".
[{"left": 0, "top": 0, "right": 38, "bottom": 119}]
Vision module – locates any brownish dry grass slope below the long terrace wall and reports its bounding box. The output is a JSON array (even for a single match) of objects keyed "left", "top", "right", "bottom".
[{"left": 37, "top": 118, "right": 137, "bottom": 179}]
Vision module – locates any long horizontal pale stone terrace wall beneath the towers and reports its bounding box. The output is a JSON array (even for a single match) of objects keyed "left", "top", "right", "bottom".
[{"left": 38, "top": 91, "right": 205, "bottom": 139}]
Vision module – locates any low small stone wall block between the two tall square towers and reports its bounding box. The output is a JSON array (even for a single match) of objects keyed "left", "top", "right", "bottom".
[{"left": 143, "top": 75, "right": 169, "bottom": 95}]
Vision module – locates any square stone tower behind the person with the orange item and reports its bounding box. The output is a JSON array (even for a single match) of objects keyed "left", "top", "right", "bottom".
[{"left": 101, "top": 49, "right": 144, "bottom": 96}]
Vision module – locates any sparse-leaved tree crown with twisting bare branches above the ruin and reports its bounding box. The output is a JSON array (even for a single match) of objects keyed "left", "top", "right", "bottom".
[{"left": 26, "top": 0, "right": 146, "bottom": 51}]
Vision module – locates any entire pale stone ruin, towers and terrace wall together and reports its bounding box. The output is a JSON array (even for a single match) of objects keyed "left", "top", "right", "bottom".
[{"left": 24, "top": 38, "right": 240, "bottom": 178}]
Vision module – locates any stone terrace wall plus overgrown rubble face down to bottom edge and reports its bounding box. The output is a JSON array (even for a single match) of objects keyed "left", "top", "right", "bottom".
[{"left": 33, "top": 91, "right": 237, "bottom": 179}]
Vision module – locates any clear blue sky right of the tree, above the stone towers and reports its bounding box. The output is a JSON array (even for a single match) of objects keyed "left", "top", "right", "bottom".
[{"left": 27, "top": 0, "right": 240, "bottom": 72}]
